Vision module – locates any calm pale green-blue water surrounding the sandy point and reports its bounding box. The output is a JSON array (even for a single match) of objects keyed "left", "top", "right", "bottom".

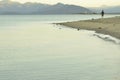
[{"left": 0, "top": 15, "right": 120, "bottom": 80}]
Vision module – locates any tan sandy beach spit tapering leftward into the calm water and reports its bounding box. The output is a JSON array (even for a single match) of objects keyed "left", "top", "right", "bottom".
[{"left": 58, "top": 16, "right": 120, "bottom": 39}]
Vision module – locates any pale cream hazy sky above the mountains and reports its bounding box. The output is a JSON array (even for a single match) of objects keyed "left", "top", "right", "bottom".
[{"left": 7, "top": 0, "right": 120, "bottom": 7}]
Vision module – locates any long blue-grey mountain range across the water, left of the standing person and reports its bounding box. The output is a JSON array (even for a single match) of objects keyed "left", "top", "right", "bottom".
[{"left": 0, "top": 0, "right": 92, "bottom": 14}]
